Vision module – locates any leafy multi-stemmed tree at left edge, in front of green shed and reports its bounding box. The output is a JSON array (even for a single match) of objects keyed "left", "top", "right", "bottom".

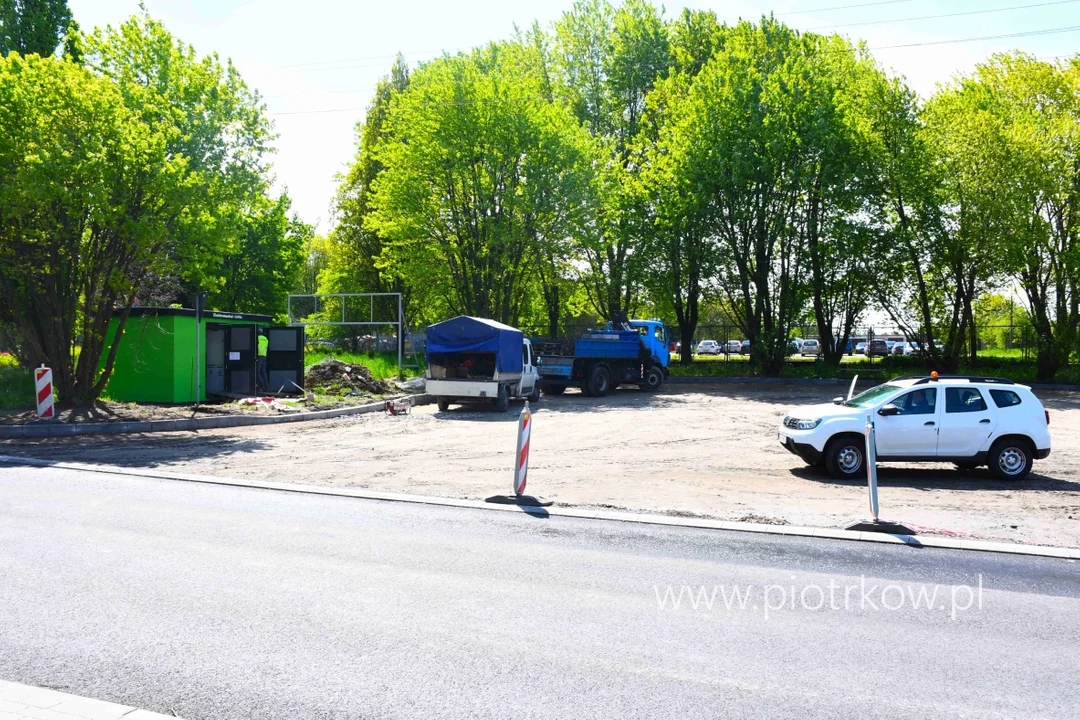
[{"left": 0, "top": 54, "right": 190, "bottom": 404}]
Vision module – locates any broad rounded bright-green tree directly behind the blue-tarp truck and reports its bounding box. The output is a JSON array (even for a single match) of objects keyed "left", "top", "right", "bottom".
[{"left": 365, "top": 42, "right": 591, "bottom": 324}]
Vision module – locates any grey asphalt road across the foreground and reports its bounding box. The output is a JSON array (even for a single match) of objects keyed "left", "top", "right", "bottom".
[{"left": 0, "top": 467, "right": 1080, "bottom": 720}]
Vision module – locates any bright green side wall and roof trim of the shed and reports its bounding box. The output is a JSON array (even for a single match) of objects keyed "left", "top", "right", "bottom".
[{"left": 102, "top": 308, "right": 271, "bottom": 403}]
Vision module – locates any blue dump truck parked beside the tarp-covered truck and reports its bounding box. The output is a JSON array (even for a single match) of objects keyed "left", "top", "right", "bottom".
[{"left": 532, "top": 320, "right": 671, "bottom": 397}]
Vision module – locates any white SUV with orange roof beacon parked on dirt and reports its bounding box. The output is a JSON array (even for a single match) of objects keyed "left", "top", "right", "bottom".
[{"left": 780, "top": 376, "right": 1050, "bottom": 480}]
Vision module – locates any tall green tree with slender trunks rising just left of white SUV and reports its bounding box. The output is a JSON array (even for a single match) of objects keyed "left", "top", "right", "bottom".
[{"left": 667, "top": 18, "right": 822, "bottom": 373}]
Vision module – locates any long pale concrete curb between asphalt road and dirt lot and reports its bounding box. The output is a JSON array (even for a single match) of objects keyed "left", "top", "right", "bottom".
[{"left": 0, "top": 456, "right": 1080, "bottom": 560}]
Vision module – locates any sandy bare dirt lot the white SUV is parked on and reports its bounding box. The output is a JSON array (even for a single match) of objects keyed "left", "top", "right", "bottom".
[{"left": 0, "top": 384, "right": 1080, "bottom": 547}]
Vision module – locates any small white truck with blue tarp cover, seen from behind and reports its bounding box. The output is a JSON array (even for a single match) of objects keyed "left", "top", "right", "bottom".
[{"left": 424, "top": 315, "right": 540, "bottom": 412}]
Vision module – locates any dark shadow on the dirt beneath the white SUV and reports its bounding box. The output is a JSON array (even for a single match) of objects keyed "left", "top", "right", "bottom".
[{"left": 791, "top": 466, "right": 1080, "bottom": 492}]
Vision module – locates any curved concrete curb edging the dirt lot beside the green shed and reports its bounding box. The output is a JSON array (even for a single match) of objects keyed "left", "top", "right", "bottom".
[{"left": 0, "top": 394, "right": 435, "bottom": 439}]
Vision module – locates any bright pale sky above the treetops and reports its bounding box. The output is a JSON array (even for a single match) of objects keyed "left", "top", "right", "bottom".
[{"left": 69, "top": 0, "right": 1080, "bottom": 233}]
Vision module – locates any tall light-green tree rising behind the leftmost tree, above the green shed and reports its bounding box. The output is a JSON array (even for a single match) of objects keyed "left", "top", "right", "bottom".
[{"left": 81, "top": 13, "right": 273, "bottom": 300}]
